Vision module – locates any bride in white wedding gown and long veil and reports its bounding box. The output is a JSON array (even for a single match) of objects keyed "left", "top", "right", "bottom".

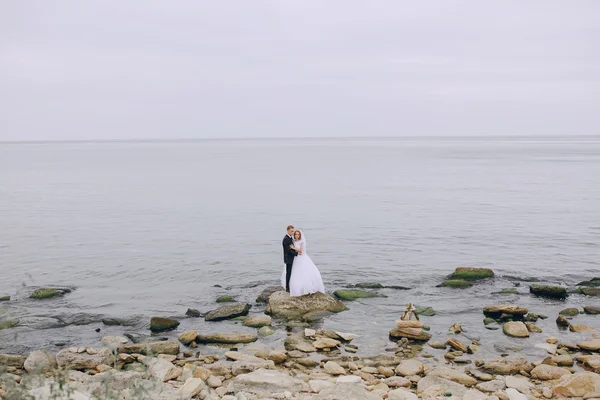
[{"left": 281, "top": 230, "right": 325, "bottom": 296}]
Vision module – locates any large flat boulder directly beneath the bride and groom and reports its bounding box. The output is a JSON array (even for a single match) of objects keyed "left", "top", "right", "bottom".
[{"left": 265, "top": 291, "right": 346, "bottom": 319}]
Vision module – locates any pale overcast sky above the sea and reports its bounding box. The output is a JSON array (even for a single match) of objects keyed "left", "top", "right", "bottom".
[{"left": 0, "top": 0, "right": 600, "bottom": 140}]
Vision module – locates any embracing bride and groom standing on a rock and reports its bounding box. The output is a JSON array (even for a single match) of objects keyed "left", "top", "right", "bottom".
[{"left": 281, "top": 225, "right": 325, "bottom": 296}]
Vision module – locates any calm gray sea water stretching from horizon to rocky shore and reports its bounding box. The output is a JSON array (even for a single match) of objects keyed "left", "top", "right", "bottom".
[{"left": 0, "top": 137, "right": 600, "bottom": 355}]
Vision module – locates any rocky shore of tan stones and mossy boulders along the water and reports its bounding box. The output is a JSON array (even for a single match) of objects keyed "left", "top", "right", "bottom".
[{"left": 0, "top": 268, "right": 600, "bottom": 400}]
